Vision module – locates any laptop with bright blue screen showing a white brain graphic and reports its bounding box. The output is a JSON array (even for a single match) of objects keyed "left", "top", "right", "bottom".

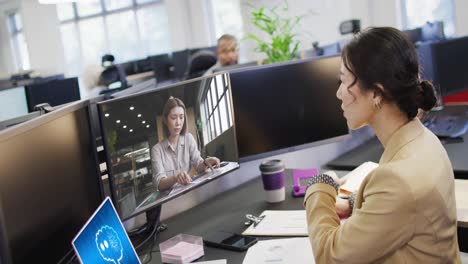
[{"left": 72, "top": 197, "right": 140, "bottom": 264}]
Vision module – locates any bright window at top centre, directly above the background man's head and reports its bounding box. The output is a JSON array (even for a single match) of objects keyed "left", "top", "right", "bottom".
[{"left": 210, "top": 0, "right": 244, "bottom": 39}]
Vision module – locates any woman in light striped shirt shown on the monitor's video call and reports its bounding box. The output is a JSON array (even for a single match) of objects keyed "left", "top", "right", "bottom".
[{"left": 151, "top": 97, "right": 220, "bottom": 190}]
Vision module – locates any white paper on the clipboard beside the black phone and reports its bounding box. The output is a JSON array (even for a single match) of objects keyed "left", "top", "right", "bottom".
[{"left": 242, "top": 210, "right": 308, "bottom": 236}]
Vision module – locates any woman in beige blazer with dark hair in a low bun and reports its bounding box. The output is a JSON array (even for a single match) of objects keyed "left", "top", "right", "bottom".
[{"left": 304, "top": 28, "right": 460, "bottom": 264}]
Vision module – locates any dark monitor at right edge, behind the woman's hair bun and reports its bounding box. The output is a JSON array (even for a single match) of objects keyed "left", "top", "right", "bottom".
[{"left": 418, "top": 36, "right": 468, "bottom": 96}]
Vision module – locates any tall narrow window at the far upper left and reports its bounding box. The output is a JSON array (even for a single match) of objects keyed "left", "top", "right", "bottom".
[{"left": 7, "top": 12, "right": 31, "bottom": 70}]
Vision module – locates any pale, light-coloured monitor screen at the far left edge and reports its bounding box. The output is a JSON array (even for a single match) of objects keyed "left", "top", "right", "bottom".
[{"left": 0, "top": 87, "right": 28, "bottom": 121}]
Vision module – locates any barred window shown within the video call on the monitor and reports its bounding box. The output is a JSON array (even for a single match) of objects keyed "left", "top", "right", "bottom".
[{"left": 202, "top": 75, "right": 233, "bottom": 145}]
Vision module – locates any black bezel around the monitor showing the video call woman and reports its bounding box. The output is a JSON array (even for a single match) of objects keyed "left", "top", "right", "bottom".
[{"left": 97, "top": 72, "right": 240, "bottom": 221}]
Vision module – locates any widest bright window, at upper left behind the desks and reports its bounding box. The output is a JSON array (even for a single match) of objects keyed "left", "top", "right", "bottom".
[{"left": 57, "top": 0, "right": 170, "bottom": 75}]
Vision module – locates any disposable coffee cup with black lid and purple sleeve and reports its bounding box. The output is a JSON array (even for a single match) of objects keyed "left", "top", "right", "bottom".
[{"left": 260, "top": 160, "right": 285, "bottom": 203}]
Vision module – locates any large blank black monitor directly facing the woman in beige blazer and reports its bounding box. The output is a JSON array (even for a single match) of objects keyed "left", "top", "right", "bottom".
[{"left": 230, "top": 56, "right": 348, "bottom": 161}]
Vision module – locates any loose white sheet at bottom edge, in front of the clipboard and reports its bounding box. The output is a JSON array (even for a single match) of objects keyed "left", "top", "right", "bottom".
[{"left": 242, "top": 237, "right": 315, "bottom": 264}]
